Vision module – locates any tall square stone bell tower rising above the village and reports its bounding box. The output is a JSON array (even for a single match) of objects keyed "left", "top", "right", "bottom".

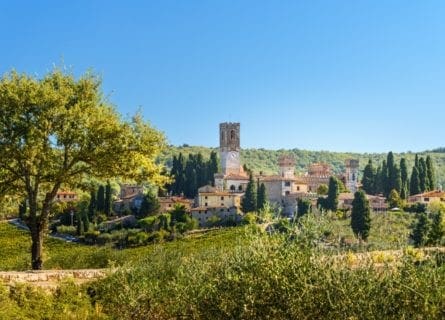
[{"left": 219, "top": 122, "right": 242, "bottom": 175}]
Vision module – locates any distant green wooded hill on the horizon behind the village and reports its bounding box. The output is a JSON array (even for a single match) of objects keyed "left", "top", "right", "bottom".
[{"left": 161, "top": 145, "right": 445, "bottom": 186}]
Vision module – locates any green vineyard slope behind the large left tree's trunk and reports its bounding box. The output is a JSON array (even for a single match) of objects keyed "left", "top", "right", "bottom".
[{"left": 0, "top": 223, "right": 248, "bottom": 271}]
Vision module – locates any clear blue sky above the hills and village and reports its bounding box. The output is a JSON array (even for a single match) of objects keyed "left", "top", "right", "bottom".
[{"left": 0, "top": 0, "right": 445, "bottom": 152}]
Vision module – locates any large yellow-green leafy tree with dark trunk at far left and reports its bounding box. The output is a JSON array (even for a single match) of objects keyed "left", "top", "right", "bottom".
[{"left": 0, "top": 70, "right": 166, "bottom": 269}]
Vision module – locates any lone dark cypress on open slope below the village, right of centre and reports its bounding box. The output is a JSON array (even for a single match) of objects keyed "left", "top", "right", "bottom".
[{"left": 351, "top": 190, "right": 371, "bottom": 241}]
